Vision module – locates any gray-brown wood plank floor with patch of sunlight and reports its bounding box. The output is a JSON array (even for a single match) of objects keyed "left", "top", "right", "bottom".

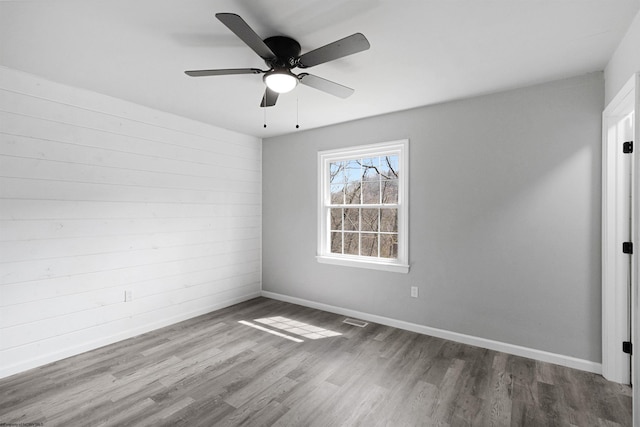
[{"left": 0, "top": 298, "right": 631, "bottom": 426}]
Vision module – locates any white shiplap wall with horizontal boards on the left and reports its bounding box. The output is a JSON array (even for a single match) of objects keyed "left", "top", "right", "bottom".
[{"left": 0, "top": 67, "right": 262, "bottom": 377}]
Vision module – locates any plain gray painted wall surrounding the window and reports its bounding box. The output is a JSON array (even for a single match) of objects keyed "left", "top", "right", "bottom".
[{"left": 263, "top": 73, "right": 604, "bottom": 362}]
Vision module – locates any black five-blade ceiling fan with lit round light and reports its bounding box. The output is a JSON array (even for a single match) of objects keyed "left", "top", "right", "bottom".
[{"left": 185, "top": 13, "right": 370, "bottom": 107}]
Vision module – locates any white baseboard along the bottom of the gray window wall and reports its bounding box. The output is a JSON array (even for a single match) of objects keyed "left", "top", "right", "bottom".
[{"left": 262, "top": 291, "right": 602, "bottom": 374}]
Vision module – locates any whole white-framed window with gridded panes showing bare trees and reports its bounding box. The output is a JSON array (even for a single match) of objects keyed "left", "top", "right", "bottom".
[{"left": 318, "top": 140, "right": 409, "bottom": 273}]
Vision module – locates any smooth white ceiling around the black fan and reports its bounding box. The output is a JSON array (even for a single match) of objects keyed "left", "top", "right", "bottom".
[{"left": 0, "top": 0, "right": 640, "bottom": 137}]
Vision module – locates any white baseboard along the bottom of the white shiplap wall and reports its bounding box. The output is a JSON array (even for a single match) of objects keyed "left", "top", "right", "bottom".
[{"left": 0, "top": 292, "right": 260, "bottom": 378}]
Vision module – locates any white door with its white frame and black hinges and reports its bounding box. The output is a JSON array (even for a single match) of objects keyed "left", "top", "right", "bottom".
[{"left": 602, "top": 76, "right": 640, "bottom": 384}]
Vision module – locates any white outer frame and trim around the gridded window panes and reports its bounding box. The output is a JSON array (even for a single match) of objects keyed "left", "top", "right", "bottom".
[{"left": 316, "top": 139, "right": 409, "bottom": 273}]
